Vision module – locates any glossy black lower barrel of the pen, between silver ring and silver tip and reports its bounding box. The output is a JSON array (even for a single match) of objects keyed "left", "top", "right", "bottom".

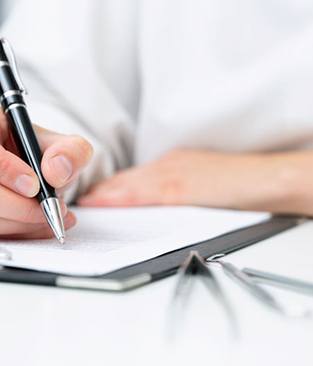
[{"left": 6, "top": 104, "right": 55, "bottom": 202}]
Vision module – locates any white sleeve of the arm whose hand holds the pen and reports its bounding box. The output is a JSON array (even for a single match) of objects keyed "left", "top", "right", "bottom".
[{"left": 1, "top": 0, "right": 134, "bottom": 200}]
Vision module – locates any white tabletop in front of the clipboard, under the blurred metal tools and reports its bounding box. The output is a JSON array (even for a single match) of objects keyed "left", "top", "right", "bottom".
[{"left": 0, "top": 222, "right": 313, "bottom": 366}]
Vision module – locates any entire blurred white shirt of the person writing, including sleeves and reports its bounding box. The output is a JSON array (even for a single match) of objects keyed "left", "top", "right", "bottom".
[{"left": 1, "top": 0, "right": 313, "bottom": 200}]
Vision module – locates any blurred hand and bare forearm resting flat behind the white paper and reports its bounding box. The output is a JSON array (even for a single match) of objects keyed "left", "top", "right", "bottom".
[{"left": 78, "top": 149, "right": 313, "bottom": 215}]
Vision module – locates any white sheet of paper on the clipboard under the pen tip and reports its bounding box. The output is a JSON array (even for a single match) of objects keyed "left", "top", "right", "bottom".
[{"left": 0, "top": 207, "right": 269, "bottom": 275}]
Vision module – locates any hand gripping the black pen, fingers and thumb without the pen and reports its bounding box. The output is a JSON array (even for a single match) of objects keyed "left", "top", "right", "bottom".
[{"left": 0, "top": 111, "right": 92, "bottom": 239}]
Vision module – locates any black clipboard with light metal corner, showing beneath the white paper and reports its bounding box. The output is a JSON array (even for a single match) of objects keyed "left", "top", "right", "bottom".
[{"left": 0, "top": 216, "right": 303, "bottom": 292}]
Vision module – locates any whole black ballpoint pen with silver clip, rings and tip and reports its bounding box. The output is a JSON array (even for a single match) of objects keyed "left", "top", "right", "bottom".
[{"left": 0, "top": 38, "right": 65, "bottom": 244}]
